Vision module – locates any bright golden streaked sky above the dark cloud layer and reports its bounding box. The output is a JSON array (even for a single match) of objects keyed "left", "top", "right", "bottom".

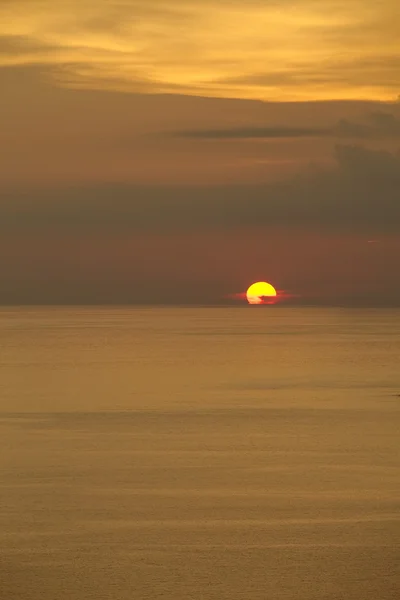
[{"left": 0, "top": 0, "right": 400, "bottom": 101}]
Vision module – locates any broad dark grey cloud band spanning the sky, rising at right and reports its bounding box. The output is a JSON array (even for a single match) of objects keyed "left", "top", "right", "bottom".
[{"left": 0, "top": 144, "right": 400, "bottom": 233}]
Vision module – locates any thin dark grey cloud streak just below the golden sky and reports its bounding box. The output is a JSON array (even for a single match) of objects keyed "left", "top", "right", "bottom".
[{"left": 172, "top": 111, "right": 400, "bottom": 140}]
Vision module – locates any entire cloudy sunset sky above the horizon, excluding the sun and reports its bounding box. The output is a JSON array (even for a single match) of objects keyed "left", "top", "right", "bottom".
[{"left": 0, "top": 0, "right": 400, "bottom": 306}]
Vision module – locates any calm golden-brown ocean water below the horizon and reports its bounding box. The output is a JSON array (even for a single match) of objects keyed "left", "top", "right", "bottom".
[{"left": 0, "top": 307, "right": 400, "bottom": 600}]
